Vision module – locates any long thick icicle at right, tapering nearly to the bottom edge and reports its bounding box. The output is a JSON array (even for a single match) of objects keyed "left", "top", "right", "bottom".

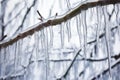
[{"left": 104, "top": 7, "right": 112, "bottom": 78}]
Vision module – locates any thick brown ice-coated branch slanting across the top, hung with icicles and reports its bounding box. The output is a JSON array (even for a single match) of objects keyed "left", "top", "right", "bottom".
[{"left": 0, "top": 0, "right": 120, "bottom": 47}]
